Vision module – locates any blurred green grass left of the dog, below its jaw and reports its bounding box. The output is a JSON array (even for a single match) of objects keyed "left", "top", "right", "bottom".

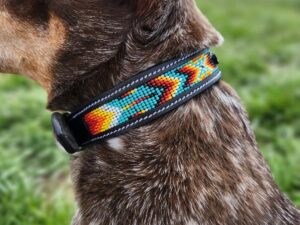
[{"left": 0, "top": 77, "right": 74, "bottom": 225}]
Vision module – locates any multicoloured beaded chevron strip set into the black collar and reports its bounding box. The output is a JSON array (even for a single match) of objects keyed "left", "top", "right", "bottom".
[{"left": 84, "top": 51, "right": 217, "bottom": 136}]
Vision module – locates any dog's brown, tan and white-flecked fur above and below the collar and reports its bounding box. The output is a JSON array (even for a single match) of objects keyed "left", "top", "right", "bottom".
[{"left": 0, "top": 0, "right": 300, "bottom": 225}]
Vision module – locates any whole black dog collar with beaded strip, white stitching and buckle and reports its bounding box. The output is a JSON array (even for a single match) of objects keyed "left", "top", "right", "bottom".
[{"left": 52, "top": 49, "right": 221, "bottom": 154}]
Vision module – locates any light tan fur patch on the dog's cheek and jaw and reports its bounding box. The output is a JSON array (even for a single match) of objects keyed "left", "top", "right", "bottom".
[{"left": 0, "top": 5, "right": 66, "bottom": 91}]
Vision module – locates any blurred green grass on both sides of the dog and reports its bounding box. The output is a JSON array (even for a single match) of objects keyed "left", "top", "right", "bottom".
[{"left": 0, "top": 0, "right": 300, "bottom": 225}]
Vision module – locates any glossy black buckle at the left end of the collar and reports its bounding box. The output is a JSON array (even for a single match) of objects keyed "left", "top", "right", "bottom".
[{"left": 51, "top": 112, "right": 80, "bottom": 154}]
